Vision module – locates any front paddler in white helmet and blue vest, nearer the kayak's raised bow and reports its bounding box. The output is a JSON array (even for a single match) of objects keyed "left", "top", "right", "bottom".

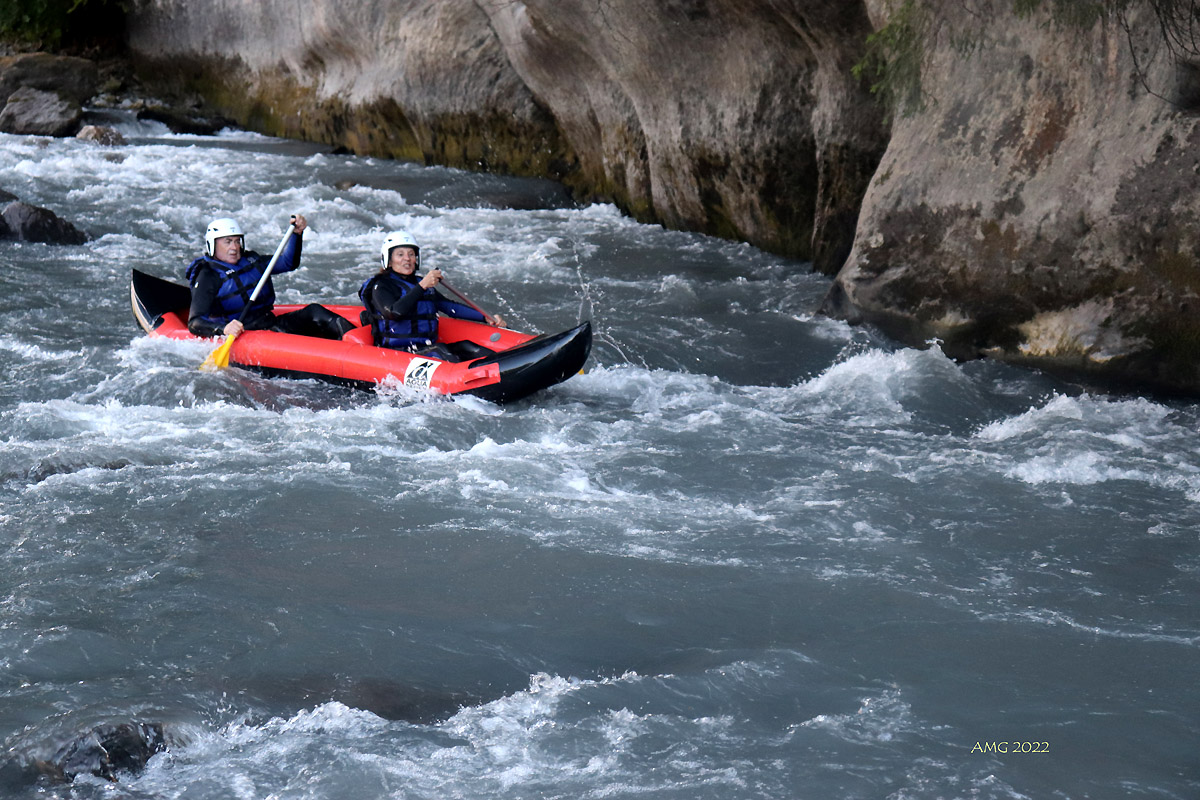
[{"left": 359, "top": 230, "right": 504, "bottom": 361}]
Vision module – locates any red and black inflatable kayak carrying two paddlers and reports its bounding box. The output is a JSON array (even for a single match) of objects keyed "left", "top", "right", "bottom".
[{"left": 130, "top": 270, "right": 592, "bottom": 403}]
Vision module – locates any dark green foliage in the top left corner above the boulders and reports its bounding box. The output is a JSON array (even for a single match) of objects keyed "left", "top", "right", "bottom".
[{"left": 0, "top": 0, "right": 133, "bottom": 49}]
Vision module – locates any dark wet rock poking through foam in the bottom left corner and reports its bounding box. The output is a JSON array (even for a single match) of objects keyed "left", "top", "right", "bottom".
[{"left": 34, "top": 722, "right": 167, "bottom": 781}]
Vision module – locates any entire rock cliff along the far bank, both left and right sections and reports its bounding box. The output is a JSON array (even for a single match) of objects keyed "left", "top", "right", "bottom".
[{"left": 130, "top": 0, "right": 1200, "bottom": 392}]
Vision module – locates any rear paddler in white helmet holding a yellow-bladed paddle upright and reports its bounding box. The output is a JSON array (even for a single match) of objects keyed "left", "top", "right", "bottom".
[{"left": 187, "top": 213, "right": 354, "bottom": 339}]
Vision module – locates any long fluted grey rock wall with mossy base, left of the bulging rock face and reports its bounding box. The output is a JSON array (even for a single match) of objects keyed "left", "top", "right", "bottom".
[{"left": 130, "top": 0, "right": 886, "bottom": 268}]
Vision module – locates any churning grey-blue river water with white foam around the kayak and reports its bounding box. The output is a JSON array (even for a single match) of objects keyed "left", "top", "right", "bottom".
[{"left": 0, "top": 115, "right": 1200, "bottom": 800}]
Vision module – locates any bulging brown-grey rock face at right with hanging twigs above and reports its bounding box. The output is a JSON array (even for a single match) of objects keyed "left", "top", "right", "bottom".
[{"left": 826, "top": 1, "right": 1200, "bottom": 392}]
